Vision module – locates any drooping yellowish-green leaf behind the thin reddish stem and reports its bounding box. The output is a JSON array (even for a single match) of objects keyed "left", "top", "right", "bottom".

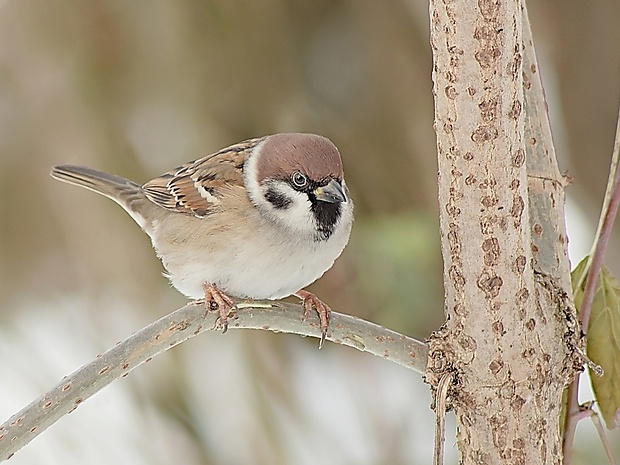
[{"left": 571, "top": 259, "right": 620, "bottom": 429}]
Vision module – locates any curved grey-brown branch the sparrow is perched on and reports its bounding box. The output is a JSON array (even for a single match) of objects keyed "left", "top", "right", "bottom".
[{"left": 0, "top": 302, "right": 427, "bottom": 460}]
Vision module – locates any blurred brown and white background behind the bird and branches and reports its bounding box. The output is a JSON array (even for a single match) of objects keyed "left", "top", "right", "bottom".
[{"left": 0, "top": 0, "right": 620, "bottom": 465}]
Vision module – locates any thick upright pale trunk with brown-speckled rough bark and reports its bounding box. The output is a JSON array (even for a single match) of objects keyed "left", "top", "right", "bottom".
[{"left": 426, "top": 0, "right": 581, "bottom": 465}]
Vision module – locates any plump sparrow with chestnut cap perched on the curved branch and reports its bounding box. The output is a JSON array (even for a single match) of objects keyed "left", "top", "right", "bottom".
[{"left": 51, "top": 133, "right": 353, "bottom": 348}]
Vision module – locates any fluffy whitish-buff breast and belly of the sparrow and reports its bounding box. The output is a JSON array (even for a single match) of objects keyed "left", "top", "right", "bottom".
[{"left": 143, "top": 197, "right": 352, "bottom": 299}]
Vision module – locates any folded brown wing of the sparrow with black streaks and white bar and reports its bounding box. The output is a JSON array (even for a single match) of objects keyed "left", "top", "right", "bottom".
[{"left": 142, "top": 138, "right": 263, "bottom": 217}]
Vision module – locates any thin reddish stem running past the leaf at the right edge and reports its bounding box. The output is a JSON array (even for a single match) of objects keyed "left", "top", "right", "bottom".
[{"left": 562, "top": 103, "right": 620, "bottom": 465}]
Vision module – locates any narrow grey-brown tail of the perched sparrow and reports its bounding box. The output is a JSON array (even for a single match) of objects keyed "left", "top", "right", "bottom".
[{"left": 50, "top": 165, "right": 150, "bottom": 229}]
